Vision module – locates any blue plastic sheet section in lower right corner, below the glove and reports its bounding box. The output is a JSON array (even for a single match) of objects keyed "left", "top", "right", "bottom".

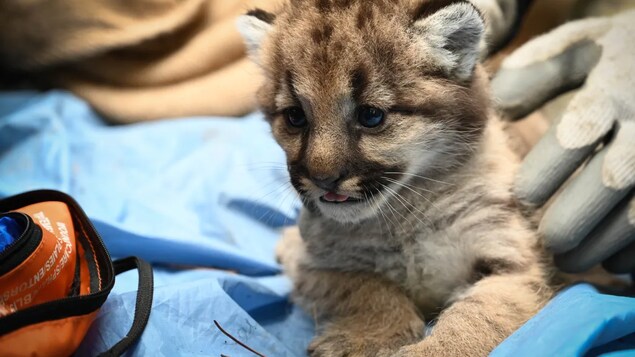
[{"left": 491, "top": 284, "right": 635, "bottom": 357}]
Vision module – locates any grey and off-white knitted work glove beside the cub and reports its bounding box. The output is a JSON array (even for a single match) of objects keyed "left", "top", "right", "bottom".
[{"left": 492, "top": 10, "right": 635, "bottom": 273}]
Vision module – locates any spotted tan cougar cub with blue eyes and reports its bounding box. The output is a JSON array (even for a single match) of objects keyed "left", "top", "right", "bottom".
[{"left": 239, "top": 0, "right": 551, "bottom": 357}]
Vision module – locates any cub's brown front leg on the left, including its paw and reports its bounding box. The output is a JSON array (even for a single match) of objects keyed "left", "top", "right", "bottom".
[{"left": 295, "top": 267, "right": 424, "bottom": 357}]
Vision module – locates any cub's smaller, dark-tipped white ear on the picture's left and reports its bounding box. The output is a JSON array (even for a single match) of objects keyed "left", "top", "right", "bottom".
[{"left": 236, "top": 9, "right": 276, "bottom": 62}]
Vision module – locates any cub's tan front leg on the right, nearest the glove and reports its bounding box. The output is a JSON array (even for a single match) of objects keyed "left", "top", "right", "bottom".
[{"left": 396, "top": 268, "right": 551, "bottom": 357}]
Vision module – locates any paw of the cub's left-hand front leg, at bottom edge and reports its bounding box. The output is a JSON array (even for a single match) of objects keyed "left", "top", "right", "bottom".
[{"left": 308, "top": 333, "right": 399, "bottom": 357}]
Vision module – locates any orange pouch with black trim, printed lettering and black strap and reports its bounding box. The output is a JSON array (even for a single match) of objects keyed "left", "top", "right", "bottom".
[{"left": 0, "top": 190, "right": 153, "bottom": 357}]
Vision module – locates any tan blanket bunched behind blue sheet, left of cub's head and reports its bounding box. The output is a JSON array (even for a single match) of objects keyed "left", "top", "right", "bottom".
[{"left": 0, "top": 0, "right": 279, "bottom": 123}]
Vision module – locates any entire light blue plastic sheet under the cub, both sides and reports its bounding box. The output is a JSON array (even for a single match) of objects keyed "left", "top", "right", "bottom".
[{"left": 0, "top": 92, "right": 635, "bottom": 357}]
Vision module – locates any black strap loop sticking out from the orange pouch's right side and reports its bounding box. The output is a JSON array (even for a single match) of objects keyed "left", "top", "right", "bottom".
[{"left": 99, "top": 257, "right": 154, "bottom": 357}]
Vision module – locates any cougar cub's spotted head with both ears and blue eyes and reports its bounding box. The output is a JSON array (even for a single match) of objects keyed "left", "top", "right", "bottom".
[{"left": 239, "top": 0, "right": 488, "bottom": 222}]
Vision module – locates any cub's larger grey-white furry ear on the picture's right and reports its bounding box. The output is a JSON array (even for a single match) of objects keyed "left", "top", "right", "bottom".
[{"left": 413, "top": 1, "right": 485, "bottom": 81}]
